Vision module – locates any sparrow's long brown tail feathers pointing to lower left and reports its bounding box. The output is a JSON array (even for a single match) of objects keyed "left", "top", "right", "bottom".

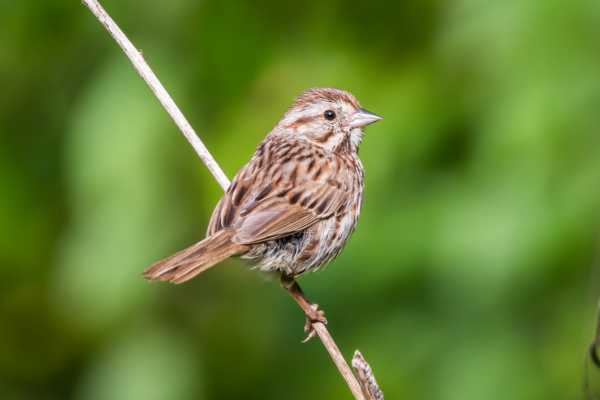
[{"left": 142, "top": 228, "right": 249, "bottom": 283}]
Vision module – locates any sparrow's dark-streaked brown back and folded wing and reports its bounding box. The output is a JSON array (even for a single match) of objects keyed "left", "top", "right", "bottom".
[{"left": 207, "top": 139, "right": 349, "bottom": 244}]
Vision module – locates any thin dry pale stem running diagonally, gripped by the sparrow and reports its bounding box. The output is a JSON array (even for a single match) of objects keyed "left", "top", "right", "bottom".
[{"left": 82, "top": 0, "right": 383, "bottom": 400}]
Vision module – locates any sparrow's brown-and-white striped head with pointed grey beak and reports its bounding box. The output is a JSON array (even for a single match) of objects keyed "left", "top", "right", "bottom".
[{"left": 276, "top": 88, "right": 381, "bottom": 152}]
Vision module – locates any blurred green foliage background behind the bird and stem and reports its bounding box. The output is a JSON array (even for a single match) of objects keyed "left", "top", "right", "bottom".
[{"left": 0, "top": 0, "right": 600, "bottom": 400}]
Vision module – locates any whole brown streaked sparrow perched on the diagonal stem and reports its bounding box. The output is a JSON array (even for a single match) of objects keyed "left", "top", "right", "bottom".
[{"left": 143, "top": 88, "right": 381, "bottom": 330}]
